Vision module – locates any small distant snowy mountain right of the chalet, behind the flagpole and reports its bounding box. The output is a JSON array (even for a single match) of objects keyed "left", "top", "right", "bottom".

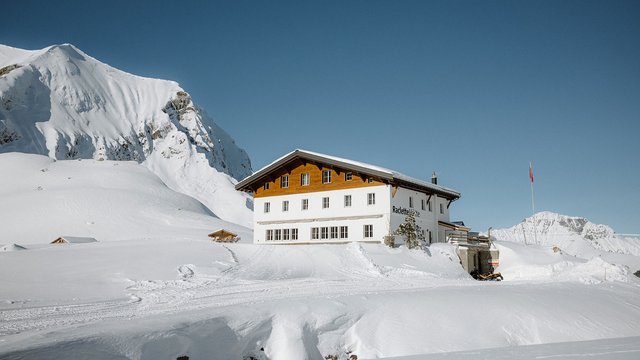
[{"left": 491, "top": 211, "right": 640, "bottom": 258}]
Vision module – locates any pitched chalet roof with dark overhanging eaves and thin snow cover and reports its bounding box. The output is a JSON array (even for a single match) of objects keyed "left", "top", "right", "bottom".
[{"left": 236, "top": 149, "right": 460, "bottom": 200}]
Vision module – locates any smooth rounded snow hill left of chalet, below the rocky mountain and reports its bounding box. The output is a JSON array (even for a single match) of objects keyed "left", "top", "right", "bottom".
[{"left": 0, "top": 153, "right": 251, "bottom": 245}]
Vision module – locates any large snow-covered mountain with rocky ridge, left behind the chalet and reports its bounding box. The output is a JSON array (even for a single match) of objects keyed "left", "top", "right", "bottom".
[{"left": 0, "top": 44, "right": 251, "bottom": 225}]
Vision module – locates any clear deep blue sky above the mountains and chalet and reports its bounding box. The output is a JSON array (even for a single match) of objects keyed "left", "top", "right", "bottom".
[{"left": 0, "top": 1, "right": 640, "bottom": 233}]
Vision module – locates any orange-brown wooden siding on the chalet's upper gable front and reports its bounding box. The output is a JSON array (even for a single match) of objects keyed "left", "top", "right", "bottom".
[{"left": 253, "top": 163, "right": 384, "bottom": 198}]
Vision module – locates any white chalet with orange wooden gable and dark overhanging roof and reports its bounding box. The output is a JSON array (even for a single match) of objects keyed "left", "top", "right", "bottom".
[{"left": 236, "top": 150, "right": 460, "bottom": 244}]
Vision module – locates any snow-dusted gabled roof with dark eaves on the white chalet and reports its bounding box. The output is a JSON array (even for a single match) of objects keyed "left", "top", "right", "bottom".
[{"left": 236, "top": 149, "right": 460, "bottom": 199}]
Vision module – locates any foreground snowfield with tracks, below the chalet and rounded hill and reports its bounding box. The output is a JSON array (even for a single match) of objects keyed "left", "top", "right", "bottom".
[{"left": 0, "top": 239, "right": 640, "bottom": 359}]
